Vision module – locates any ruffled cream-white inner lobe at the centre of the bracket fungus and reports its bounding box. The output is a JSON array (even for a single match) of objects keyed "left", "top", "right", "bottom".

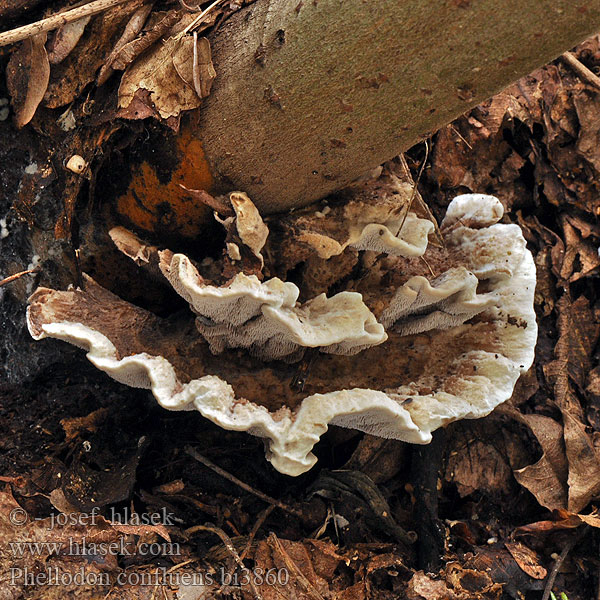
[{"left": 161, "top": 252, "right": 387, "bottom": 360}]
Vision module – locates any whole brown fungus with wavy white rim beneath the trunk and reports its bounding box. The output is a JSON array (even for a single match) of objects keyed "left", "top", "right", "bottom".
[{"left": 27, "top": 166, "right": 537, "bottom": 475}]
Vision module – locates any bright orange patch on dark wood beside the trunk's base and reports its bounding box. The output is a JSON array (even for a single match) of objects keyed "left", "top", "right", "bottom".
[{"left": 117, "top": 129, "right": 213, "bottom": 237}]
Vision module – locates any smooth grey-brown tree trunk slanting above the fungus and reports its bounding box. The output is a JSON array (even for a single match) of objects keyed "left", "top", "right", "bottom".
[{"left": 197, "top": 0, "right": 600, "bottom": 213}]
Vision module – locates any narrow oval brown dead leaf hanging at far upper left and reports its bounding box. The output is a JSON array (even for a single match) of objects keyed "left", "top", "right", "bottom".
[{"left": 6, "top": 33, "right": 50, "bottom": 127}]
